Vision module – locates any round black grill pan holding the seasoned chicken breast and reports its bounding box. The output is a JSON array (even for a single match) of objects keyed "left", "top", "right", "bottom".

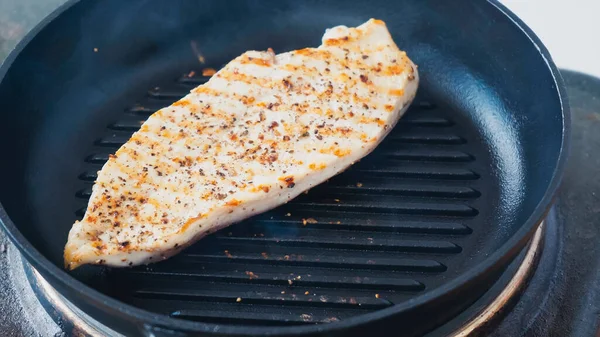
[{"left": 0, "top": 0, "right": 569, "bottom": 336}]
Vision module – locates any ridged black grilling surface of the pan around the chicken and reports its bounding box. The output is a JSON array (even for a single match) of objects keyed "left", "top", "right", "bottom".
[{"left": 73, "top": 69, "right": 496, "bottom": 325}]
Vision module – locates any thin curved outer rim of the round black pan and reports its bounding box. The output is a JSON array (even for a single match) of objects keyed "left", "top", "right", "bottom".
[{"left": 0, "top": 0, "right": 571, "bottom": 336}]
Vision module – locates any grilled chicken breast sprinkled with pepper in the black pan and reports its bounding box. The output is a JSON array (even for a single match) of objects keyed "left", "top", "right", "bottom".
[{"left": 64, "top": 19, "right": 418, "bottom": 269}]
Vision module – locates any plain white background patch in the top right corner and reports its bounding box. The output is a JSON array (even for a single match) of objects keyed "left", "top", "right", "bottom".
[{"left": 500, "top": 0, "right": 600, "bottom": 77}]
